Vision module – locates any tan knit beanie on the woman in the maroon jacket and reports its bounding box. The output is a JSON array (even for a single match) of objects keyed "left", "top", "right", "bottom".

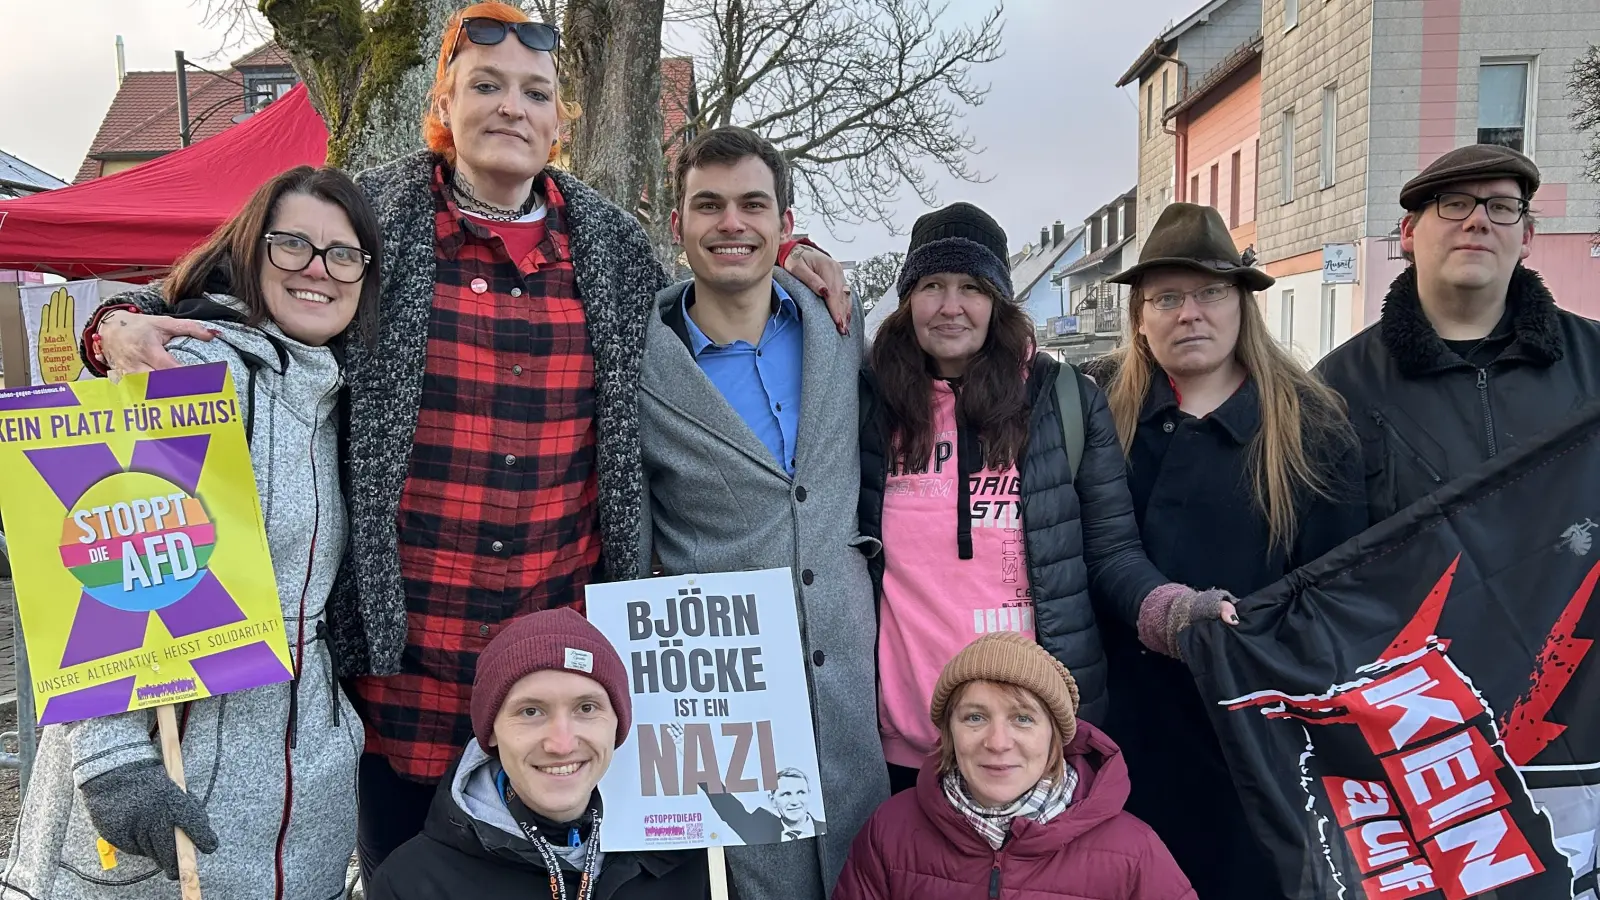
[{"left": 930, "top": 631, "right": 1078, "bottom": 745}]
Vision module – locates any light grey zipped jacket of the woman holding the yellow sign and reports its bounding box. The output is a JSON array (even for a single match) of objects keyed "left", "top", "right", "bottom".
[{"left": 0, "top": 295, "right": 363, "bottom": 900}]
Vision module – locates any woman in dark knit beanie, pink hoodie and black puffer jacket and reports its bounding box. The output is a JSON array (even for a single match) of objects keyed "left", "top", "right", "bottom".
[{"left": 861, "top": 203, "right": 1232, "bottom": 791}]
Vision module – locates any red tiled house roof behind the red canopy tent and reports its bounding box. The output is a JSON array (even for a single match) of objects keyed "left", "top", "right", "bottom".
[{"left": 74, "top": 72, "right": 245, "bottom": 181}]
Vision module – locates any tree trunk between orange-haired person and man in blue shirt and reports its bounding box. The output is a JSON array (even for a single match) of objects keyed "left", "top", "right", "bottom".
[{"left": 562, "top": 0, "right": 666, "bottom": 221}]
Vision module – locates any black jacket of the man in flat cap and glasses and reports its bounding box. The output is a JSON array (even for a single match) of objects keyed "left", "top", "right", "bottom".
[{"left": 1317, "top": 266, "right": 1600, "bottom": 522}]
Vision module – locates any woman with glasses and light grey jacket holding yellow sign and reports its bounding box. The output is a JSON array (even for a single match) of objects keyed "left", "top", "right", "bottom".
[{"left": 0, "top": 167, "right": 382, "bottom": 900}]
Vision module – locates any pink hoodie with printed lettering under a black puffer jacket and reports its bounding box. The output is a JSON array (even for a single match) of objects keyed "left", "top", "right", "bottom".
[{"left": 878, "top": 381, "right": 1034, "bottom": 767}]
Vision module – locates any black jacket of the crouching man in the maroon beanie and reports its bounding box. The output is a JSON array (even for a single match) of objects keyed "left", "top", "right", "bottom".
[{"left": 366, "top": 752, "right": 710, "bottom": 900}]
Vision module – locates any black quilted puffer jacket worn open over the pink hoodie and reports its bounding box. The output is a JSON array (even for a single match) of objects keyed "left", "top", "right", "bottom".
[{"left": 861, "top": 354, "right": 1168, "bottom": 724}]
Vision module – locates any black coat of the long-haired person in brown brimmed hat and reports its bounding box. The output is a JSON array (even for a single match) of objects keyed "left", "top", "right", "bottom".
[{"left": 1091, "top": 358, "right": 1366, "bottom": 900}]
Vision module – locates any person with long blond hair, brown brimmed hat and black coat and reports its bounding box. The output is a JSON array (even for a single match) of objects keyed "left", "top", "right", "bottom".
[{"left": 1088, "top": 203, "right": 1366, "bottom": 900}]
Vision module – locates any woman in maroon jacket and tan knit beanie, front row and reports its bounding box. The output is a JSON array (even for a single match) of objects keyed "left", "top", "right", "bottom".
[{"left": 834, "top": 631, "right": 1203, "bottom": 900}]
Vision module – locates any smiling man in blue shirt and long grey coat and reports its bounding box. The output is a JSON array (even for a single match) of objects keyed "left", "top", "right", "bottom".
[{"left": 638, "top": 128, "right": 888, "bottom": 900}]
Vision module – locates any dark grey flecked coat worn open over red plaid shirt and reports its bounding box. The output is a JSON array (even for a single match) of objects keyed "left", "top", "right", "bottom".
[{"left": 84, "top": 151, "right": 667, "bottom": 676}]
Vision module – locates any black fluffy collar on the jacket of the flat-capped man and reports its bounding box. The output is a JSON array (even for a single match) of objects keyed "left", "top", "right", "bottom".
[{"left": 1379, "top": 264, "right": 1562, "bottom": 378}]
